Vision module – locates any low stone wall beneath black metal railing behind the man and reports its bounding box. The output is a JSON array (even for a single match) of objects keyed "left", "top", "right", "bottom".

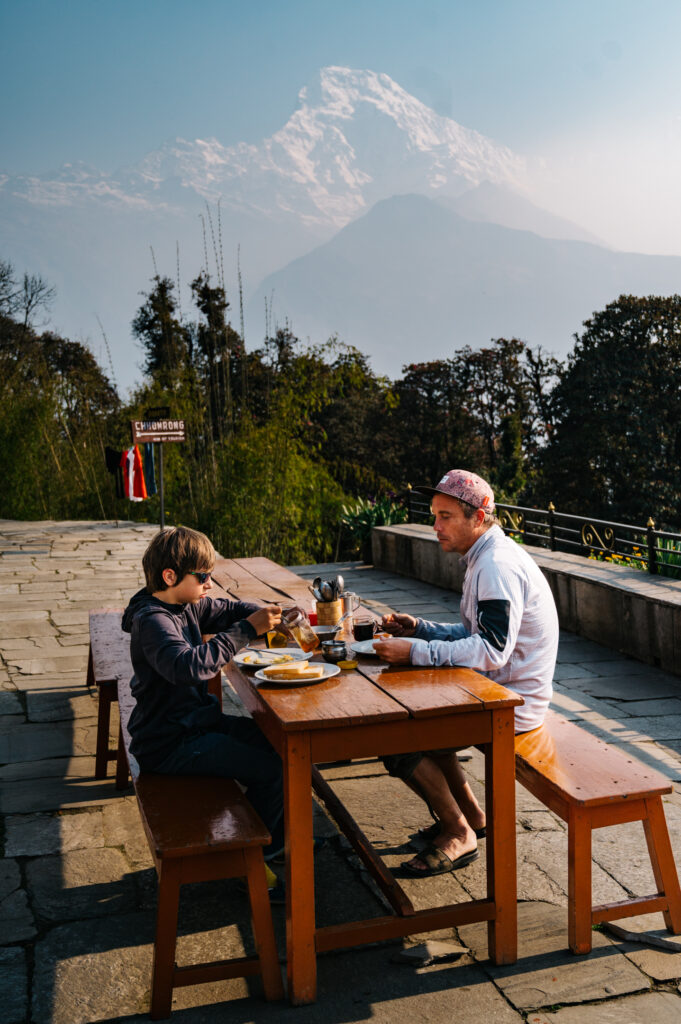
[{"left": 372, "top": 523, "right": 681, "bottom": 676}]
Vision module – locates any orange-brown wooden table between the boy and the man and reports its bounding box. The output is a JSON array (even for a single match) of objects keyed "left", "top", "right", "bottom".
[{"left": 215, "top": 559, "right": 522, "bottom": 1004}]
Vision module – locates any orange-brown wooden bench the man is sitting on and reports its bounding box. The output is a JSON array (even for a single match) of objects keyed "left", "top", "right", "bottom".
[{"left": 515, "top": 713, "right": 681, "bottom": 953}]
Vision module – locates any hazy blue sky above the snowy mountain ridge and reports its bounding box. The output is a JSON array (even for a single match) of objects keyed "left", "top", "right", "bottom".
[{"left": 0, "top": 0, "right": 681, "bottom": 254}]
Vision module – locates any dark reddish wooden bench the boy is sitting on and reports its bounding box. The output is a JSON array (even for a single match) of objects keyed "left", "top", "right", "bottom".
[{"left": 117, "top": 678, "right": 284, "bottom": 1020}]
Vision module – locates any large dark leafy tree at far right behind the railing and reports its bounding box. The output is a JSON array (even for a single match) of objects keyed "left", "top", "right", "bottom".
[{"left": 542, "top": 295, "right": 681, "bottom": 525}]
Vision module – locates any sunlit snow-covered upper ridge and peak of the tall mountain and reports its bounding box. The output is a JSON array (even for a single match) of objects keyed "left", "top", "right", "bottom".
[{"left": 0, "top": 68, "right": 524, "bottom": 228}]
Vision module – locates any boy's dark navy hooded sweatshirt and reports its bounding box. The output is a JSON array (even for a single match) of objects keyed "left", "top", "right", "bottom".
[{"left": 122, "top": 589, "right": 259, "bottom": 771}]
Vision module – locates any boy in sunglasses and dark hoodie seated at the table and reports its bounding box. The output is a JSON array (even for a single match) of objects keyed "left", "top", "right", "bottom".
[{"left": 123, "top": 526, "right": 284, "bottom": 859}]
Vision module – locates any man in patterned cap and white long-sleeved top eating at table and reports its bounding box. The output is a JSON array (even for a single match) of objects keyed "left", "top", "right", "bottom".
[{"left": 375, "top": 469, "right": 558, "bottom": 877}]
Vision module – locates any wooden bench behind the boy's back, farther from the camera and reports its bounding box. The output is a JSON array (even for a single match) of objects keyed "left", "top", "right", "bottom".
[{"left": 85, "top": 608, "right": 222, "bottom": 790}]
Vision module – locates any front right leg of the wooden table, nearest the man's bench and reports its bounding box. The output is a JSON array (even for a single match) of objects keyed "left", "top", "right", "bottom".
[{"left": 484, "top": 708, "right": 518, "bottom": 964}]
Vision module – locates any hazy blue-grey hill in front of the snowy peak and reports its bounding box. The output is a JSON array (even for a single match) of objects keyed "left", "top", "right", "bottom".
[{"left": 251, "top": 196, "right": 681, "bottom": 376}]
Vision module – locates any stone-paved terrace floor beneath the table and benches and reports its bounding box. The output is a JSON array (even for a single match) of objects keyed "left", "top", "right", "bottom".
[{"left": 0, "top": 521, "right": 681, "bottom": 1024}]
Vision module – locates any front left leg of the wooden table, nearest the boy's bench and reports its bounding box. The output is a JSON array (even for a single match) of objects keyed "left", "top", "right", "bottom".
[{"left": 283, "top": 733, "right": 316, "bottom": 1005}]
